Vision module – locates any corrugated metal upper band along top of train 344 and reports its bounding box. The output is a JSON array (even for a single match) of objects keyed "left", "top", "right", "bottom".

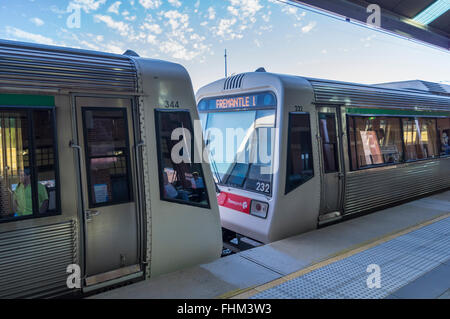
[{"left": 0, "top": 41, "right": 137, "bottom": 93}]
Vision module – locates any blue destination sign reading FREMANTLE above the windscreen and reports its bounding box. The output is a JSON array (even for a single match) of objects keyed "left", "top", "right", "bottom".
[{"left": 198, "top": 92, "right": 276, "bottom": 111}]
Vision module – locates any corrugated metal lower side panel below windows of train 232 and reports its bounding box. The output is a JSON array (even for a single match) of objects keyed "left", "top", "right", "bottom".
[{"left": 344, "top": 158, "right": 450, "bottom": 214}]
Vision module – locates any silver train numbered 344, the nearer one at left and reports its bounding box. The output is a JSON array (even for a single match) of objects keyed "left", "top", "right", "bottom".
[{"left": 0, "top": 41, "right": 222, "bottom": 298}]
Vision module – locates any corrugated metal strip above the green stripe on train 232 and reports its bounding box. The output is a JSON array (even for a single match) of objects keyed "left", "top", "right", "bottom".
[{"left": 308, "top": 79, "right": 450, "bottom": 111}]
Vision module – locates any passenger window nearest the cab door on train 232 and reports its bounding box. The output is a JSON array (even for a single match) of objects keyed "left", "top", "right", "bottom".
[{"left": 348, "top": 116, "right": 403, "bottom": 170}]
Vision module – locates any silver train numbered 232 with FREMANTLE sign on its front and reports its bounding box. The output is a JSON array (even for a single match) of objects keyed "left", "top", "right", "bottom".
[{"left": 196, "top": 70, "right": 450, "bottom": 243}]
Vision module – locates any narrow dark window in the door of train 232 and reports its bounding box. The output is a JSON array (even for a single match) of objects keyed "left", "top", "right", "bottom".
[{"left": 319, "top": 113, "right": 339, "bottom": 173}]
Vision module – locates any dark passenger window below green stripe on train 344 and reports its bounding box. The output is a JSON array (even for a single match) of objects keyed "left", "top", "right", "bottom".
[{"left": 0, "top": 109, "right": 59, "bottom": 221}]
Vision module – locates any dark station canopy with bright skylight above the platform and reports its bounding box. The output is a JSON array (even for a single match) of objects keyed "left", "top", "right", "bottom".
[{"left": 290, "top": 0, "right": 450, "bottom": 50}]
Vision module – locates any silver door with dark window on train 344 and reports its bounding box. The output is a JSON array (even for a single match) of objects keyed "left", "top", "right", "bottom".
[{"left": 75, "top": 97, "right": 141, "bottom": 291}]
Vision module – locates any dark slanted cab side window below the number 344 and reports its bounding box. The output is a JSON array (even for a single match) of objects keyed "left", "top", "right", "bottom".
[{"left": 155, "top": 110, "right": 210, "bottom": 208}]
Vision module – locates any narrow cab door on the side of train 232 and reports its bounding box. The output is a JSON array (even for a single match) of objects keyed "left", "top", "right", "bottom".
[{"left": 318, "top": 107, "right": 344, "bottom": 220}]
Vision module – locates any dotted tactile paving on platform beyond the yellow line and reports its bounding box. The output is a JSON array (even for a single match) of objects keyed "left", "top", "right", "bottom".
[{"left": 250, "top": 215, "right": 450, "bottom": 299}]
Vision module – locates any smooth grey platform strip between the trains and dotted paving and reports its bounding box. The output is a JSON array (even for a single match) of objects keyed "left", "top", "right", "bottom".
[{"left": 90, "top": 191, "right": 450, "bottom": 299}]
